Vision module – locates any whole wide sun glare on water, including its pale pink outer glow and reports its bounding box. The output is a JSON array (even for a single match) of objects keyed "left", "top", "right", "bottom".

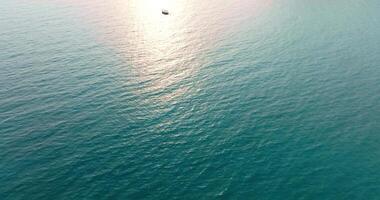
[{"left": 87, "top": 0, "right": 269, "bottom": 100}]
